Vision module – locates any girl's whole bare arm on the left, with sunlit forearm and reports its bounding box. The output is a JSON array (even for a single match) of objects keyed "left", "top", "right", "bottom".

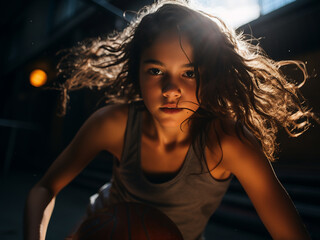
[{"left": 24, "top": 106, "right": 127, "bottom": 240}]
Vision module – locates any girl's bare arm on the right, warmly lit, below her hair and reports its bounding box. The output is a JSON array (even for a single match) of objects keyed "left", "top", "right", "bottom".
[{"left": 214, "top": 121, "right": 310, "bottom": 240}]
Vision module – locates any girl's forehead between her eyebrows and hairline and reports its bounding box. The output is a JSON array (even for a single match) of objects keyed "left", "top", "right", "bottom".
[{"left": 140, "top": 30, "right": 193, "bottom": 64}]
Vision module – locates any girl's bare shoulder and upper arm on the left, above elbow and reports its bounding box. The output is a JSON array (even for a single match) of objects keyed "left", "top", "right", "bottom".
[{"left": 38, "top": 105, "right": 128, "bottom": 195}]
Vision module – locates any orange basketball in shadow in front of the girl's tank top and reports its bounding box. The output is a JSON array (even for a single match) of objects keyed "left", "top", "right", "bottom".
[{"left": 73, "top": 203, "right": 183, "bottom": 240}]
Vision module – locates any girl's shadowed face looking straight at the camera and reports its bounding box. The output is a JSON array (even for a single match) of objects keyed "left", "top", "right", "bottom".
[{"left": 139, "top": 31, "right": 199, "bottom": 127}]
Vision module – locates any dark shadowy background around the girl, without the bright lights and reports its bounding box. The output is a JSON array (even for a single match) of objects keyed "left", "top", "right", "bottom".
[{"left": 0, "top": 0, "right": 320, "bottom": 239}]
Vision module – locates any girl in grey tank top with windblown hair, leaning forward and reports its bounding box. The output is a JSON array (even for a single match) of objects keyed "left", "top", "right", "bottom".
[{"left": 25, "top": 1, "right": 316, "bottom": 240}]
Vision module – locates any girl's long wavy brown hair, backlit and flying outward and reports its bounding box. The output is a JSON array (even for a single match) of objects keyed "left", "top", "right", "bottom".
[{"left": 58, "top": 0, "right": 318, "bottom": 161}]
